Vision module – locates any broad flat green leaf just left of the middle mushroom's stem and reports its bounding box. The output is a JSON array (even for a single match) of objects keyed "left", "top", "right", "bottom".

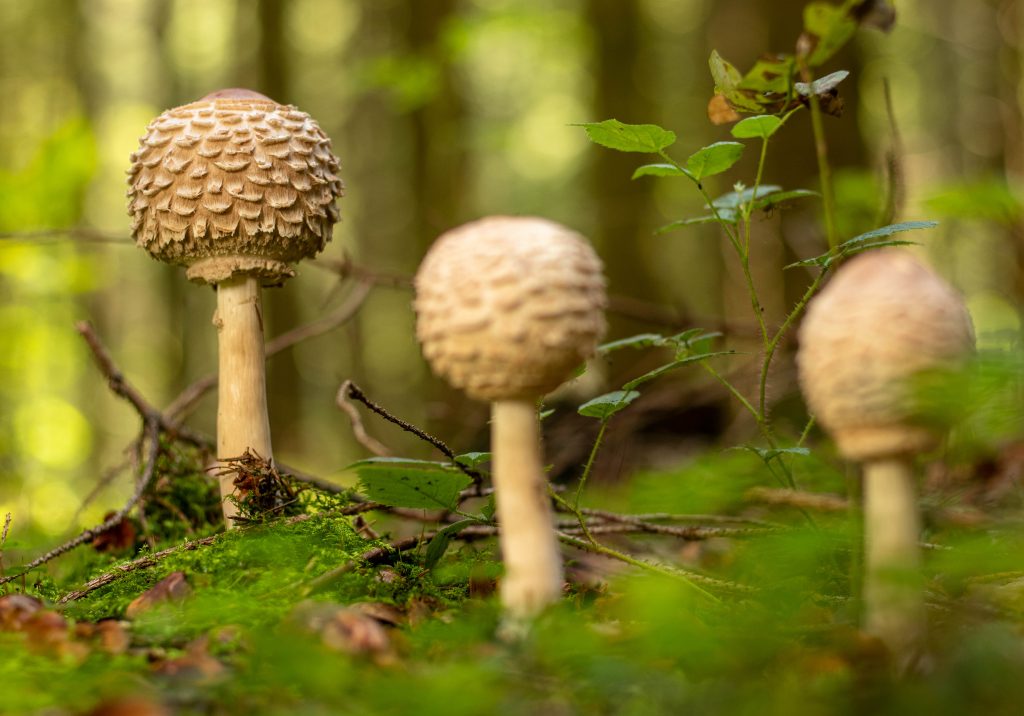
[{"left": 350, "top": 458, "right": 472, "bottom": 510}]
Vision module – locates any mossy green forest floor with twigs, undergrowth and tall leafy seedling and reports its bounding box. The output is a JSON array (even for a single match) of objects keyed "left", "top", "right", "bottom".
[{"left": 0, "top": 0, "right": 1024, "bottom": 716}]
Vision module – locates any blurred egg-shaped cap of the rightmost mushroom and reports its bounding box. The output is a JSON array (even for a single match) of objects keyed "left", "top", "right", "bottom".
[{"left": 797, "top": 249, "right": 974, "bottom": 461}]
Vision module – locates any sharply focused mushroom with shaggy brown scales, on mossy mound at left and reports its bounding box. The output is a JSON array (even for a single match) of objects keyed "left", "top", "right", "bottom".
[{"left": 128, "top": 89, "right": 342, "bottom": 525}]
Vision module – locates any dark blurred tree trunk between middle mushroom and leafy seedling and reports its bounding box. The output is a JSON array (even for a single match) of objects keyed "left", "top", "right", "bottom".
[{"left": 587, "top": 0, "right": 657, "bottom": 333}]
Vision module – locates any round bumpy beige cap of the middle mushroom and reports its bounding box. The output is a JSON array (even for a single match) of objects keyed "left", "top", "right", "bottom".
[{"left": 415, "top": 216, "right": 606, "bottom": 401}]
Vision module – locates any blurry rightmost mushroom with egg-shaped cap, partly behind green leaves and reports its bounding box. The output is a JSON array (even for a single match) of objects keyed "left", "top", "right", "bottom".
[{"left": 797, "top": 249, "right": 974, "bottom": 662}]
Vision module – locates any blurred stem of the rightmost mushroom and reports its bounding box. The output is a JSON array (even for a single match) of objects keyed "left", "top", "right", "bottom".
[{"left": 864, "top": 457, "right": 925, "bottom": 660}]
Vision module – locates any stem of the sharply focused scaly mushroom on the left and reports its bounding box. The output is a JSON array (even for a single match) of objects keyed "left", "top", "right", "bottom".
[{"left": 213, "top": 275, "right": 273, "bottom": 528}]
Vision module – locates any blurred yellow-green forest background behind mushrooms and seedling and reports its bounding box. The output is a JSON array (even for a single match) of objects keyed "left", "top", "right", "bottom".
[{"left": 0, "top": 0, "right": 1024, "bottom": 534}]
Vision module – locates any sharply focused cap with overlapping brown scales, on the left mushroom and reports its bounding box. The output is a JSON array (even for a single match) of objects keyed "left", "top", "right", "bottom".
[{"left": 128, "top": 89, "right": 342, "bottom": 284}]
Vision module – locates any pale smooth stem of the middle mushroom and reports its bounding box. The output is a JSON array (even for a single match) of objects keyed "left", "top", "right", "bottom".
[{"left": 490, "top": 399, "right": 563, "bottom": 618}]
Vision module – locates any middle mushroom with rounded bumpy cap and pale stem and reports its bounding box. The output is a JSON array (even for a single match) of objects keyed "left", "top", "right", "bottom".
[{"left": 415, "top": 216, "right": 605, "bottom": 618}]
